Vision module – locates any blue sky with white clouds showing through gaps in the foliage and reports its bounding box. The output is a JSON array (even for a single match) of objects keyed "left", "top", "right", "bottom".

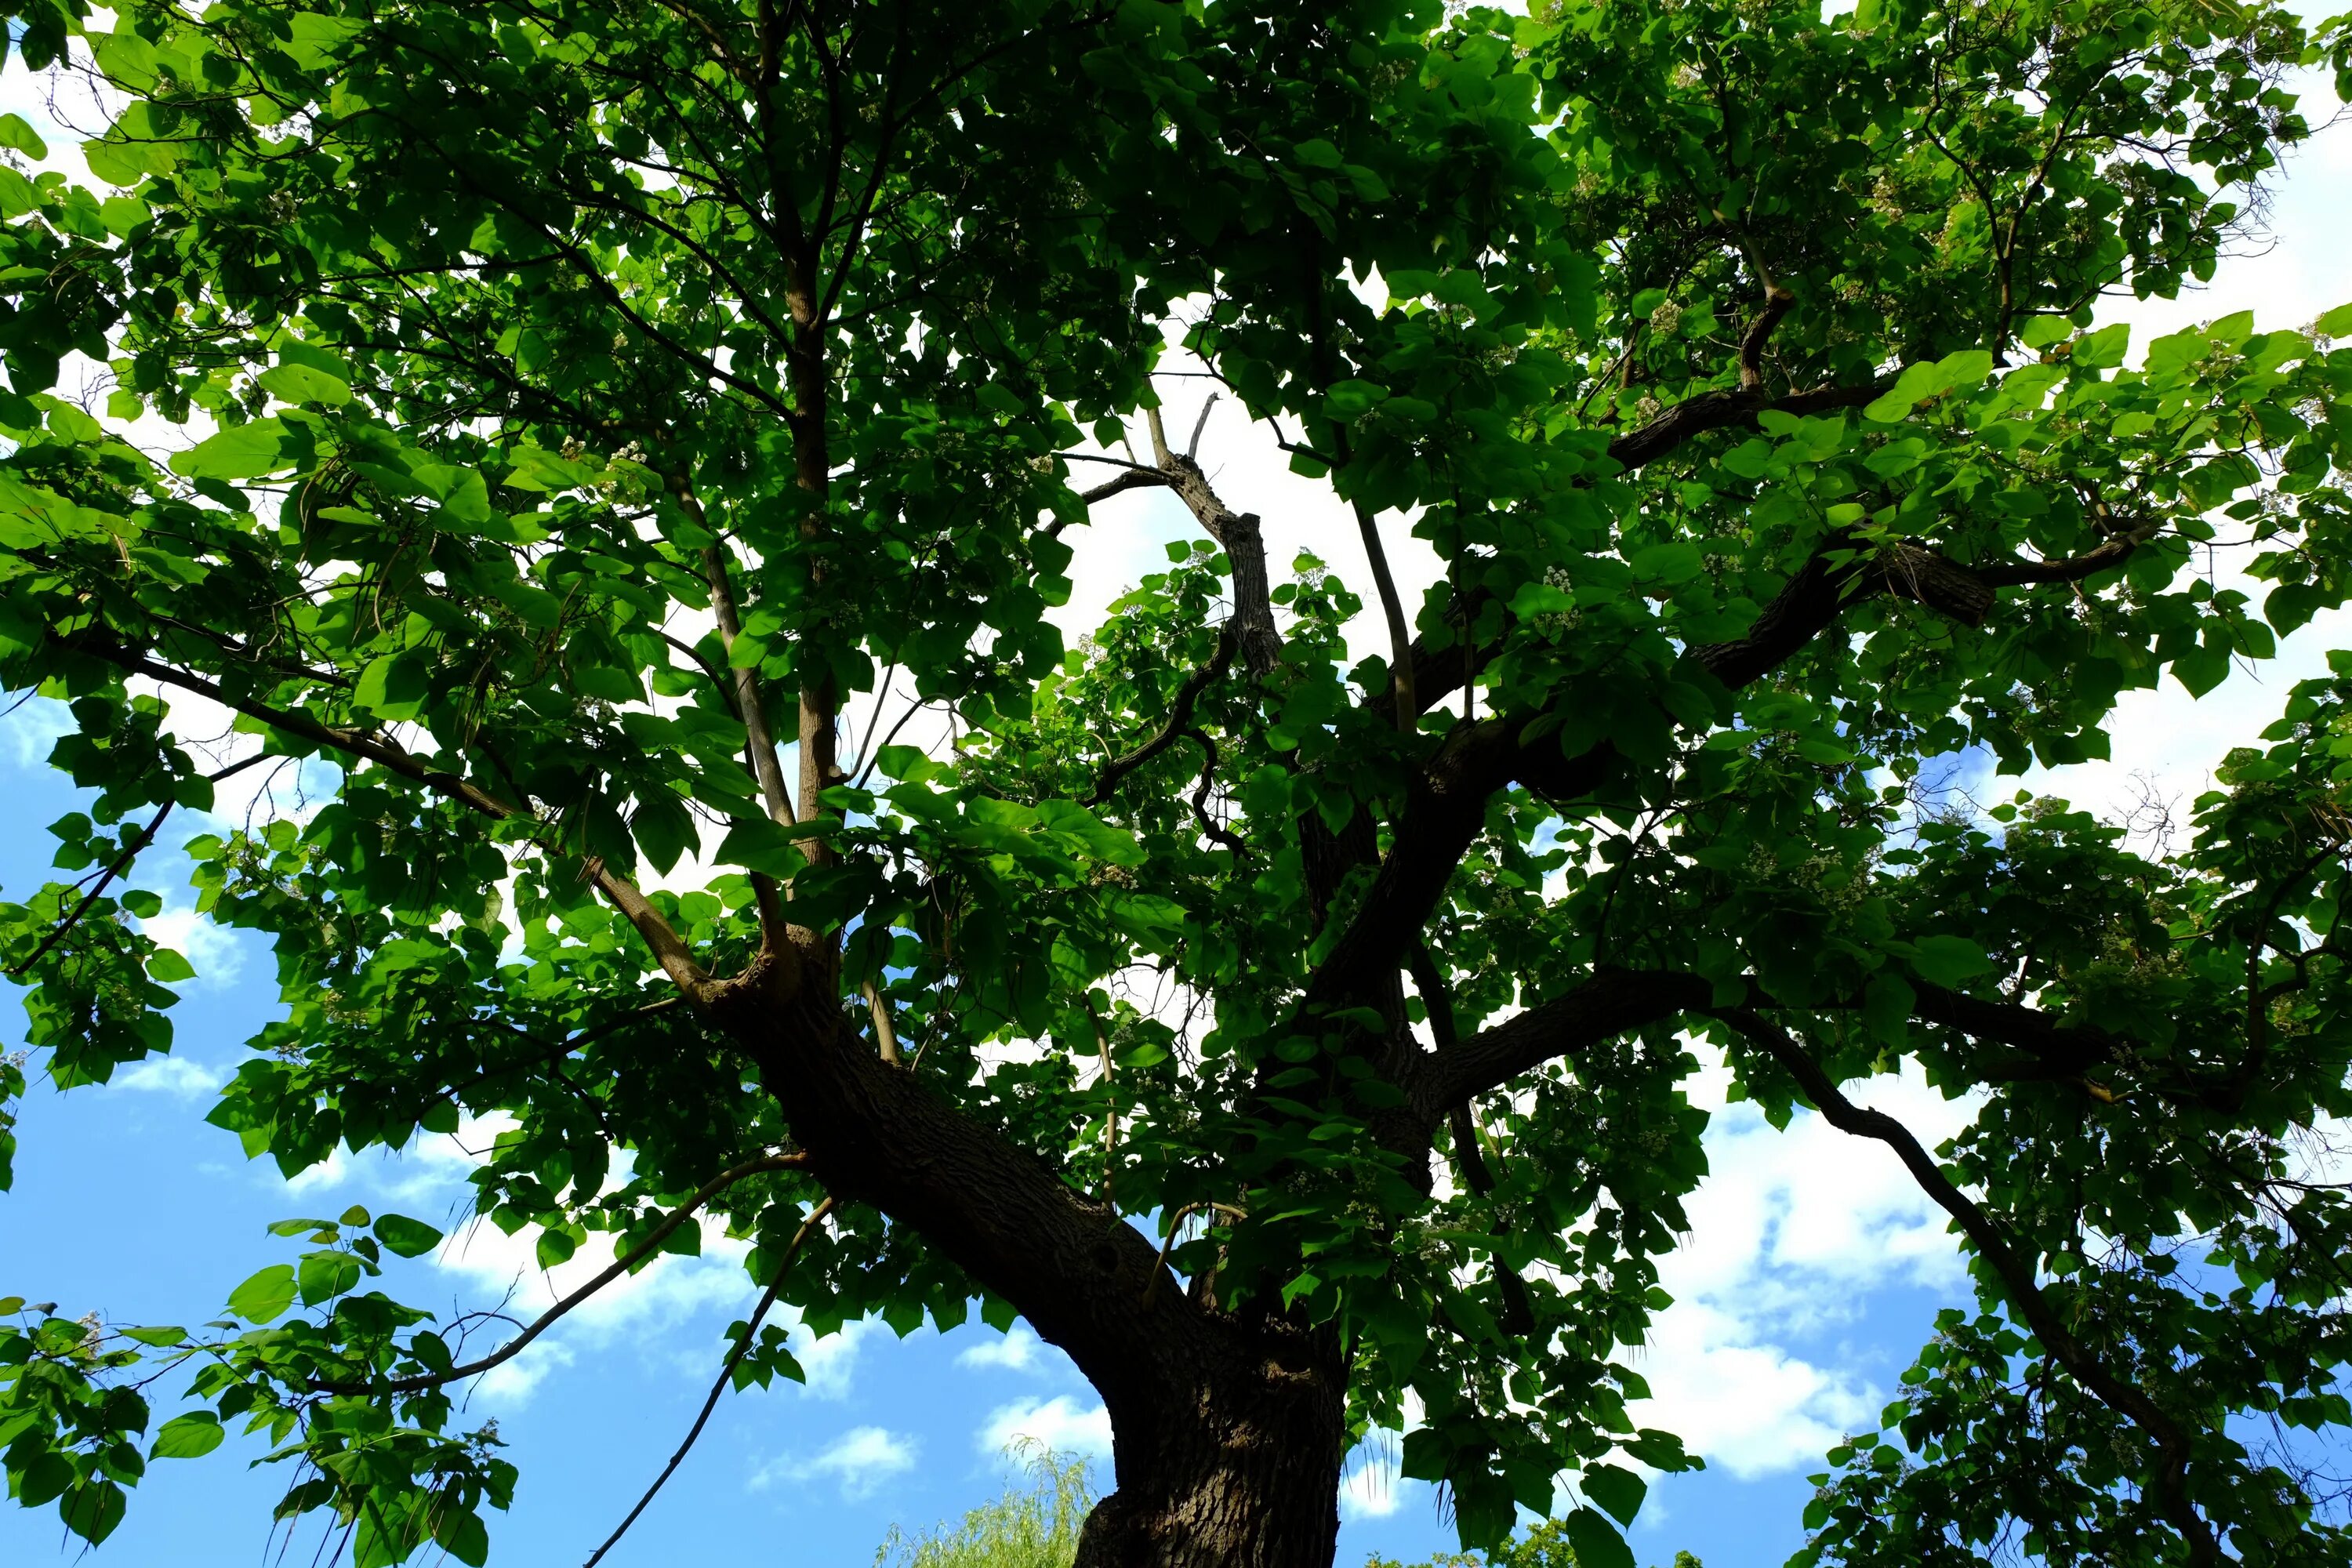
[{"left": 0, "top": 12, "right": 2352, "bottom": 1568}]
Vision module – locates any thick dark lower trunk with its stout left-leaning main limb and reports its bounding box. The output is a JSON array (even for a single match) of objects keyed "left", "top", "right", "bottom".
[{"left": 715, "top": 982, "right": 1348, "bottom": 1568}]
